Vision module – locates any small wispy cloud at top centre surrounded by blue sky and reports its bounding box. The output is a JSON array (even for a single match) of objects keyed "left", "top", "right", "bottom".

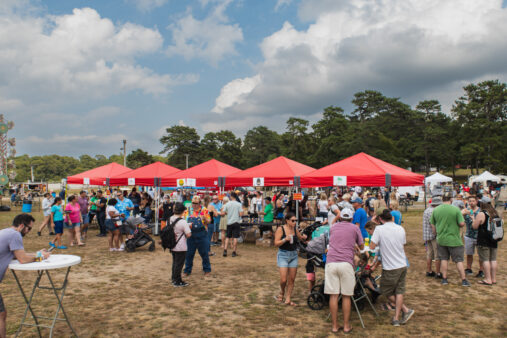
[{"left": 167, "top": 0, "right": 243, "bottom": 66}]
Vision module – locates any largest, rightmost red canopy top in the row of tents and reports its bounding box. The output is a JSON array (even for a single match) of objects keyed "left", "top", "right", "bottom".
[{"left": 301, "top": 153, "right": 424, "bottom": 187}]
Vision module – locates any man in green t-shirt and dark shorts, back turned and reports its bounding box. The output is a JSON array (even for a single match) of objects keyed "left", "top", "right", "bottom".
[{"left": 430, "top": 193, "right": 470, "bottom": 287}]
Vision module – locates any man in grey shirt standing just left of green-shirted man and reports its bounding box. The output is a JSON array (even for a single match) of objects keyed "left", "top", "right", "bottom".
[{"left": 423, "top": 196, "right": 442, "bottom": 278}]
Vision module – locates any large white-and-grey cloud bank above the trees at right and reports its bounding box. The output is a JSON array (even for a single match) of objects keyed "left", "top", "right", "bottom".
[{"left": 212, "top": 0, "right": 507, "bottom": 131}]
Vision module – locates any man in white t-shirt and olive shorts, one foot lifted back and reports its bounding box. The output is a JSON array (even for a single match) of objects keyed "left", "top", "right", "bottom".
[{"left": 370, "top": 209, "right": 415, "bottom": 326}]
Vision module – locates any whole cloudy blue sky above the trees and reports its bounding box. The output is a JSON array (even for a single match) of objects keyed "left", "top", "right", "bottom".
[{"left": 0, "top": 0, "right": 507, "bottom": 156}]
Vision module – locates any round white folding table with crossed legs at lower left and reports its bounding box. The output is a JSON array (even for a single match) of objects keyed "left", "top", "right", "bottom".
[{"left": 9, "top": 255, "right": 81, "bottom": 337}]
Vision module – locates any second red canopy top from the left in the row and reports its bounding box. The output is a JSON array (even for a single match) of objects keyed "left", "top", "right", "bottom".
[{"left": 109, "top": 162, "right": 181, "bottom": 187}]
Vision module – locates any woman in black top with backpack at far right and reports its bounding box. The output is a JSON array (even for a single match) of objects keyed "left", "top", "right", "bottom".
[{"left": 472, "top": 197, "right": 498, "bottom": 286}]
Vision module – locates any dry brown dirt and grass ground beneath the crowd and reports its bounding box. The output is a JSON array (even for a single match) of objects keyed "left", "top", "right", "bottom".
[{"left": 0, "top": 210, "right": 507, "bottom": 337}]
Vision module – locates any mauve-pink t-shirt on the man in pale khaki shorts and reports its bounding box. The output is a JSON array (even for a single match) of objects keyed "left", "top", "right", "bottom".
[{"left": 326, "top": 222, "right": 364, "bottom": 266}]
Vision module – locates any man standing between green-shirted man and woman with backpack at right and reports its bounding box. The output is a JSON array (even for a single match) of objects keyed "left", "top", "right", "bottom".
[{"left": 461, "top": 195, "right": 484, "bottom": 278}]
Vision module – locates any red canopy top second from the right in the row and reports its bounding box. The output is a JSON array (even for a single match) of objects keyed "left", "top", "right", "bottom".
[{"left": 225, "top": 156, "right": 315, "bottom": 187}]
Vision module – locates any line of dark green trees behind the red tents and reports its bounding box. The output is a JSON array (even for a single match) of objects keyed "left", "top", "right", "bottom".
[{"left": 12, "top": 80, "right": 507, "bottom": 181}]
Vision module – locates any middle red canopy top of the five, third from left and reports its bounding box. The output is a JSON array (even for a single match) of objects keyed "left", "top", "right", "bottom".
[{"left": 162, "top": 159, "right": 241, "bottom": 187}]
